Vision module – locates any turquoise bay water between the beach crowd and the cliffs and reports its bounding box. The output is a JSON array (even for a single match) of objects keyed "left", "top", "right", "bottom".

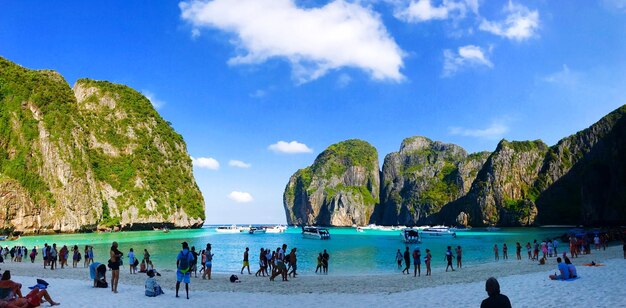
[{"left": 2, "top": 227, "right": 567, "bottom": 274}]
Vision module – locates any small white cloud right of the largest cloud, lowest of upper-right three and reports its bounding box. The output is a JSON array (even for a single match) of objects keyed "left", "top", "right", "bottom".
[{"left": 442, "top": 45, "right": 493, "bottom": 77}]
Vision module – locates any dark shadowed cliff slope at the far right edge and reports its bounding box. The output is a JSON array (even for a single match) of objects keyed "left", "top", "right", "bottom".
[{"left": 535, "top": 105, "right": 626, "bottom": 225}]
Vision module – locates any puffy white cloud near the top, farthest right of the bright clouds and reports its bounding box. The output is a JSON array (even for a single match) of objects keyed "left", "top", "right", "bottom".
[{"left": 479, "top": 1, "right": 539, "bottom": 41}]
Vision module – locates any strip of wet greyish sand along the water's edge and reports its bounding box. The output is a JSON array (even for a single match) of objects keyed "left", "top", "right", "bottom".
[{"left": 0, "top": 245, "right": 623, "bottom": 294}]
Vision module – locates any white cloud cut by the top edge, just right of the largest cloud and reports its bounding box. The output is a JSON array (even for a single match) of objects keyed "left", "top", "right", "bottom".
[{"left": 394, "top": 0, "right": 478, "bottom": 23}]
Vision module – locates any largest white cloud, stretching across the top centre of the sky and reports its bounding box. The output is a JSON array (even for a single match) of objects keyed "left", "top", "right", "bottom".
[{"left": 179, "top": 0, "right": 404, "bottom": 83}]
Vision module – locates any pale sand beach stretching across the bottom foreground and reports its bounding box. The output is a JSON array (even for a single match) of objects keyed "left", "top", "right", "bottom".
[{"left": 0, "top": 245, "right": 626, "bottom": 307}]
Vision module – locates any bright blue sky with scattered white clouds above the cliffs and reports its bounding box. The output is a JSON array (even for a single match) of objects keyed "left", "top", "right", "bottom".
[{"left": 0, "top": 0, "right": 626, "bottom": 224}]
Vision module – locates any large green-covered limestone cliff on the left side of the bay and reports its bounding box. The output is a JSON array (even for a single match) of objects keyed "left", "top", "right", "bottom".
[{"left": 0, "top": 58, "right": 204, "bottom": 233}]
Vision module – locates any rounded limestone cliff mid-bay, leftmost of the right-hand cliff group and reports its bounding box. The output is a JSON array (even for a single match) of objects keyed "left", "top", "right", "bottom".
[{"left": 283, "top": 140, "right": 380, "bottom": 226}]
